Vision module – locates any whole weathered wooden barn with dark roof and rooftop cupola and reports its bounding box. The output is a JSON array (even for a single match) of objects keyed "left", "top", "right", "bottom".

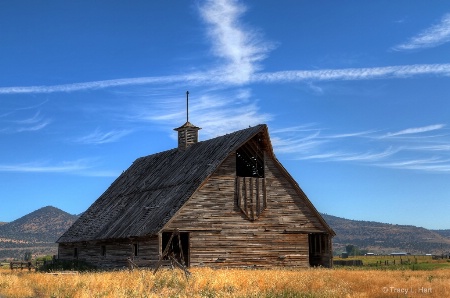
[{"left": 57, "top": 121, "right": 335, "bottom": 268}]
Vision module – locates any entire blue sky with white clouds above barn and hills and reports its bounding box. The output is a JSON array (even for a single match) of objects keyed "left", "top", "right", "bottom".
[{"left": 0, "top": 0, "right": 450, "bottom": 229}]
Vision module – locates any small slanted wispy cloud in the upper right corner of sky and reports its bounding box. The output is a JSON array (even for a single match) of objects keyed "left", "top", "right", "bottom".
[{"left": 392, "top": 13, "right": 450, "bottom": 51}]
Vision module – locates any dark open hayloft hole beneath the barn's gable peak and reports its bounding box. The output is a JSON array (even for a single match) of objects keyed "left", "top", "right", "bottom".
[{"left": 236, "top": 134, "right": 264, "bottom": 178}]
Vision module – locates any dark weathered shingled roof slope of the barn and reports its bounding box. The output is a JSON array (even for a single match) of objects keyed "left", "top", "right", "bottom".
[{"left": 57, "top": 124, "right": 266, "bottom": 243}]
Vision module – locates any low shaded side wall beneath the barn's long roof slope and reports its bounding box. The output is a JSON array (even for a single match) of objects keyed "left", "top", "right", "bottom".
[{"left": 58, "top": 236, "right": 159, "bottom": 268}]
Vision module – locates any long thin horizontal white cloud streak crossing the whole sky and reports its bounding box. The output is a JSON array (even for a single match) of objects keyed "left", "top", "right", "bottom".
[{"left": 0, "top": 63, "right": 450, "bottom": 95}]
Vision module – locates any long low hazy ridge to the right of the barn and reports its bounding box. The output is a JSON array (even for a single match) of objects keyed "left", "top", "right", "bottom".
[{"left": 322, "top": 214, "right": 450, "bottom": 254}]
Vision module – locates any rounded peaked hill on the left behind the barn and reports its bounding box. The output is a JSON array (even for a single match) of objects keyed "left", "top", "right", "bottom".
[{"left": 0, "top": 206, "right": 78, "bottom": 260}]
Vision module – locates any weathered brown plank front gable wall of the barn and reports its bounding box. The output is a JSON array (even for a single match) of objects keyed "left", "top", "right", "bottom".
[{"left": 165, "top": 154, "right": 326, "bottom": 267}]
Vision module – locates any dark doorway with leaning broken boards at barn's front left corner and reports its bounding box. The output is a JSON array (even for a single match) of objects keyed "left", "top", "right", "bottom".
[{"left": 162, "top": 232, "right": 189, "bottom": 267}]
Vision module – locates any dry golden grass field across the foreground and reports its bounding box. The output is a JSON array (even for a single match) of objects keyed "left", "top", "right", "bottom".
[{"left": 0, "top": 268, "right": 450, "bottom": 298}]
